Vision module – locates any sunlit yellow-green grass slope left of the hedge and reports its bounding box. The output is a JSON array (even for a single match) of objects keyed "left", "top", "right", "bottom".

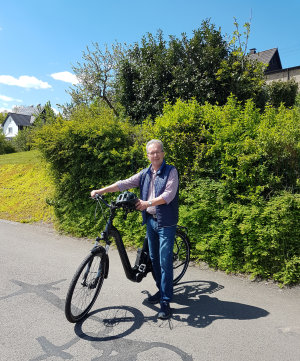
[{"left": 0, "top": 151, "right": 54, "bottom": 223}]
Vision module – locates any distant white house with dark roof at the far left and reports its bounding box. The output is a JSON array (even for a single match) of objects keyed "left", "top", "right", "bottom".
[{"left": 2, "top": 106, "right": 39, "bottom": 140}]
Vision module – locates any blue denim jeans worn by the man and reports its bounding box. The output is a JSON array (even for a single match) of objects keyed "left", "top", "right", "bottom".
[{"left": 147, "top": 216, "right": 176, "bottom": 302}]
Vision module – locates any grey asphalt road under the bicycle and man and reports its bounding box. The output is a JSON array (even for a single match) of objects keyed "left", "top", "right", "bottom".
[{"left": 0, "top": 220, "right": 300, "bottom": 361}]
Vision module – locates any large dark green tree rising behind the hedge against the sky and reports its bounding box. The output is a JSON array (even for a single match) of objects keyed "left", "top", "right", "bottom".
[{"left": 116, "top": 20, "right": 228, "bottom": 123}]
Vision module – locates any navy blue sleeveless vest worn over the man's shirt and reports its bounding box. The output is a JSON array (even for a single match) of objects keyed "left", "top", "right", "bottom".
[{"left": 140, "top": 160, "right": 179, "bottom": 227}]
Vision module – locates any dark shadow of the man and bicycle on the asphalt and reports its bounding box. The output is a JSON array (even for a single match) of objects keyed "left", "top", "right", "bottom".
[{"left": 75, "top": 281, "right": 269, "bottom": 341}]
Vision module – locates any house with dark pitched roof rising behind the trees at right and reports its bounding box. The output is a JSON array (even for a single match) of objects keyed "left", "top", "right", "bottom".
[{"left": 248, "top": 48, "right": 300, "bottom": 88}]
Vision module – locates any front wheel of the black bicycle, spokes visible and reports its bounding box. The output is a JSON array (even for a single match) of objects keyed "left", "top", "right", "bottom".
[{"left": 65, "top": 250, "right": 107, "bottom": 323}]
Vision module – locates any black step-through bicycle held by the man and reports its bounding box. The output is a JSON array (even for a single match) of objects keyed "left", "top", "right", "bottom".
[{"left": 65, "top": 192, "right": 190, "bottom": 323}]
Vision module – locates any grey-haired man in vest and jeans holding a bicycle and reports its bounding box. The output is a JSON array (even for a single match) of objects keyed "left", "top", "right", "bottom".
[{"left": 91, "top": 139, "right": 179, "bottom": 319}]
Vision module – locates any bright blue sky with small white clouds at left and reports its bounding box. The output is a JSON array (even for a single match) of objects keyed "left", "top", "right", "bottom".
[{"left": 0, "top": 0, "right": 300, "bottom": 111}]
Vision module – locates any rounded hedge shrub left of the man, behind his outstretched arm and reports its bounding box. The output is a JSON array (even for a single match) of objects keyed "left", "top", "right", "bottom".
[{"left": 35, "top": 104, "right": 144, "bottom": 235}]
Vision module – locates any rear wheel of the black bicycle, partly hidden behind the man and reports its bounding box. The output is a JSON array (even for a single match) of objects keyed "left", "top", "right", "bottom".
[{"left": 173, "top": 228, "right": 190, "bottom": 285}]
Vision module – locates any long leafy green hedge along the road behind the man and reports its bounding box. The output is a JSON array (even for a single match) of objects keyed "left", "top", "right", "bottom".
[{"left": 36, "top": 97, "right": 300, "bottom": 284}]
